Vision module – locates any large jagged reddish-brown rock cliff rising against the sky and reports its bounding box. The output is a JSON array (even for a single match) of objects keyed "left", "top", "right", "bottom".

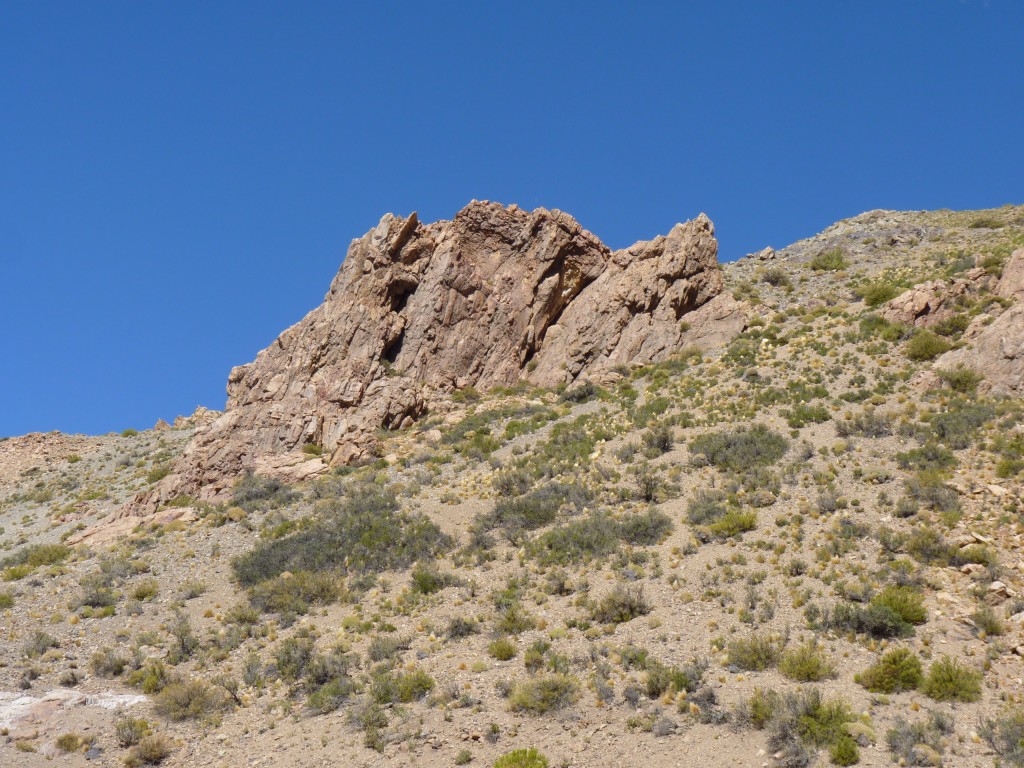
[{"left": 134, "top": 202, "right": 745, "bottom": 509}]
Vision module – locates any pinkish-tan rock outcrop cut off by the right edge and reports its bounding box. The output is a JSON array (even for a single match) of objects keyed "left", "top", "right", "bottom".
[{"left": 935, "top": 249, "right": 1024, "bottom": 397}]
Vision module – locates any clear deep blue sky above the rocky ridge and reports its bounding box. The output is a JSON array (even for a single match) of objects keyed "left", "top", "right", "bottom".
[{"left": 0, "top": 0, "right": 1024, "bottom": 435}]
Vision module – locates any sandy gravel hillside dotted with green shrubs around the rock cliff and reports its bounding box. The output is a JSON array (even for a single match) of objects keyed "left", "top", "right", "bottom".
[{"left": 0, "top": 207, "right": 1024, "bottom": 768}]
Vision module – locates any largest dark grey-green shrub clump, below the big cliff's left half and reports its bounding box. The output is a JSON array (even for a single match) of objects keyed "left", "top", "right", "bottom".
[{"left": 231, "top": 488, "right": 452, "bottom": 587}]
